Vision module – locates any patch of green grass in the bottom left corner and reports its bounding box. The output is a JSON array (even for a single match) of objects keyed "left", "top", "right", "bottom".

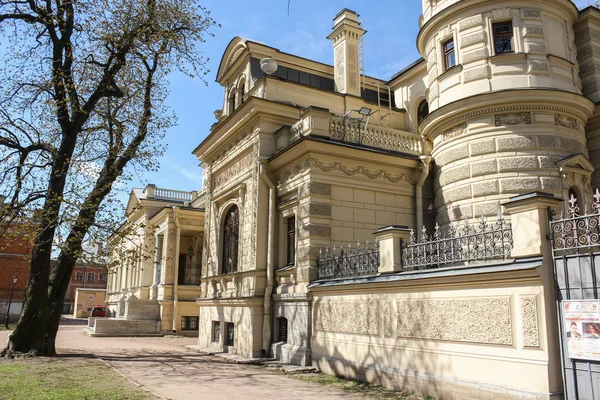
[{"left": 0, "top": 357, "right": 156, "bottom": 400}]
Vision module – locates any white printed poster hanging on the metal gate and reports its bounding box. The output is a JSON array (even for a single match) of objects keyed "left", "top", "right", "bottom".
[{"left": 562, "top": 300, "right": 600, "bottom": 361}]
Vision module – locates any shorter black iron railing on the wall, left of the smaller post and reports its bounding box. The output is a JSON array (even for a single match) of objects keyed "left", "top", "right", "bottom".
[{"left": 317, "top": 241, "right": 379, "bottom": 279}]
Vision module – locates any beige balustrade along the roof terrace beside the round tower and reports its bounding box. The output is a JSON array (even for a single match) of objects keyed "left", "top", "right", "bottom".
[{"left": 329, "top": 118, "right": 422, "bottom": 155}]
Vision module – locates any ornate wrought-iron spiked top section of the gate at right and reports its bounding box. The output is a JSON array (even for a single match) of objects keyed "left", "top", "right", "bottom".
[{"left": 550, "top": 189, "right": 600, "bottom": 256}]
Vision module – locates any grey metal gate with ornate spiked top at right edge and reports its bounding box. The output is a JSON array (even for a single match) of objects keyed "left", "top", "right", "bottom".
[{"left": 549, "top": 189, "right": 600, "bottom": 400}]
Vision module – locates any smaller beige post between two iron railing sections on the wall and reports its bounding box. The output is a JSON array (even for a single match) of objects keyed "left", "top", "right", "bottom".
[{"left": 375, "top": 225, "right": 410, "bottom": 274}]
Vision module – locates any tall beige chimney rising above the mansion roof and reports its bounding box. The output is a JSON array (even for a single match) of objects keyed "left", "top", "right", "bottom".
[{"left": 327, "top": 8, "right": 367, "bottom": 96}]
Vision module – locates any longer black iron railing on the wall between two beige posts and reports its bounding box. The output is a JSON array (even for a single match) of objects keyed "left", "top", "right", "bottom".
[{"left": 402, "top": 213, "right": 513, "bottom": 269}]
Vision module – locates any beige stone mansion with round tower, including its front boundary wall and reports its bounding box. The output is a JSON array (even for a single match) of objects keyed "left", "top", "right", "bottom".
[{"left": 108, "top": 0, "right": 600, "bottom": 399}]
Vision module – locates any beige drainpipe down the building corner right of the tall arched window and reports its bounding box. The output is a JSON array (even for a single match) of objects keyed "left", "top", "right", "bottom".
[{"left": 260, "top": 159, "right": 277, "bottom": 354}]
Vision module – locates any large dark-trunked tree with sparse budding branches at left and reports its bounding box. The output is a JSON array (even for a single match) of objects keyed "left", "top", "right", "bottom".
[{"left": 0, "top": 0, "right": 216, "bottom": 355}]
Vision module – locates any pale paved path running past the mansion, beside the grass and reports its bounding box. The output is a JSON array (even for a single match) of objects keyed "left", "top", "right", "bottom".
[{"left": 0, "top": 325, "right": 362, "bottom": 400}]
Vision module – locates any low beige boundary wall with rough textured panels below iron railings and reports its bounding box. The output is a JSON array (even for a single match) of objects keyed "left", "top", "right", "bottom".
[{"left": 311, "top": 267, "right": 560, "bottom": 400}]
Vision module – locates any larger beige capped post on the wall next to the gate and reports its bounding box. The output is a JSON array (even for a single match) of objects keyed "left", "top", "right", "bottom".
[{"left": 503, "top": 192, "right": 562, "bottom": 258}]
